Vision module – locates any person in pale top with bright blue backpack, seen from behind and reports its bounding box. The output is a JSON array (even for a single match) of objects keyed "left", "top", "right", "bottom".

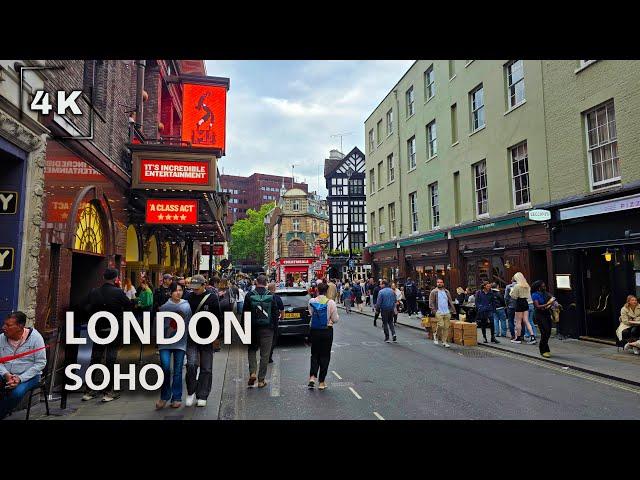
[{"left": 309, "top": 283, "right": 339, "bottom": 390}]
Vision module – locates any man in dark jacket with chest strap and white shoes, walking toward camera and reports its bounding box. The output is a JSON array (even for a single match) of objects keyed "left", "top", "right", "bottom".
[{"left": 186, "top": 275, "right": 224, "bottom": 407}]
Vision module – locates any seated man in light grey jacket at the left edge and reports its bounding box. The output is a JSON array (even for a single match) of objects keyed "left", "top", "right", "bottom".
[{"left": 0, "top": 311, "right": 47, "bottom": 420}]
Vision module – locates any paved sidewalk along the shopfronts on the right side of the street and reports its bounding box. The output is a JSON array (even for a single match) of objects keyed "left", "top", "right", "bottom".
[{"left": 339, "top": 305, "right": 640, "bottom": 386}]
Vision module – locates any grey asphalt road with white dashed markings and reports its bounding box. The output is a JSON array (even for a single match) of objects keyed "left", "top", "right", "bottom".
[{"left": 219, "top": 312, "right": 640, "bottom": 420}]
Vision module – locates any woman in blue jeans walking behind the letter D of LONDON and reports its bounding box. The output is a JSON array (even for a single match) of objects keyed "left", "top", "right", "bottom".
[{"left": 156, "top": 283, "right": 191, "bottom": 410}]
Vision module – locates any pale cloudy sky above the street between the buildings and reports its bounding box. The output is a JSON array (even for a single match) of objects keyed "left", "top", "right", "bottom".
[{"left": 206, "top": 60, "right": 413, "bottom": 196}]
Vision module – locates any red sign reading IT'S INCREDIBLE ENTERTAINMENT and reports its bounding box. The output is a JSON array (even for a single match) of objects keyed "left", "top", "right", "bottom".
[{"left": 140, "top": 158, "right": 209, "bottom": 185}]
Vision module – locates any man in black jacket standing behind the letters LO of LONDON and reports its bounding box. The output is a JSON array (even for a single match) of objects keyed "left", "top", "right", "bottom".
[{"left": 82, "top": 268, "right": 136, "bottom": 402}]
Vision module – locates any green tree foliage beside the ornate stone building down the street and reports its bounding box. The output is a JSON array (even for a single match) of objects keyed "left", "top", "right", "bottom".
[{"left": 229, "top": 202, "right": 275, "bottom": 265}]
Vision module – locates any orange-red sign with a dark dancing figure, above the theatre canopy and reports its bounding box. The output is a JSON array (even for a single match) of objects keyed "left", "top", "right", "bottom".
[{"left": 182, "top": 83, "right": 227, "bottom": 150}]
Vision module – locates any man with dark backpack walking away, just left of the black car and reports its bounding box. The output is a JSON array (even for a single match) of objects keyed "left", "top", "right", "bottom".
[{"left": 244, "top": 274, "right": 279, "bottom": 388}]
